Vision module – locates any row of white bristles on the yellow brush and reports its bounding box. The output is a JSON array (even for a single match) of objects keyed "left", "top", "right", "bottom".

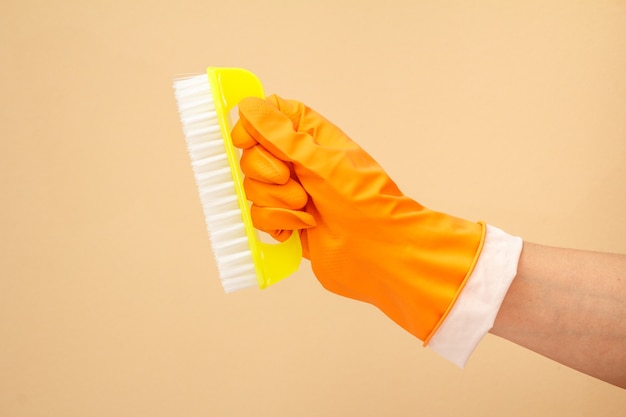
[{"left": 174, "top": 74, "right": 257, "bottom": 293}]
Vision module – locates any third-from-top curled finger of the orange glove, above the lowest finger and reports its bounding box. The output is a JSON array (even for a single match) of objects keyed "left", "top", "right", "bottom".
[{"left": 243, "top": 177, "right": 309, "bottom": 210}]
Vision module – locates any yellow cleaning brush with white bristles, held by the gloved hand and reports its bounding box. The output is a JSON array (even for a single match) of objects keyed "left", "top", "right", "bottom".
[{"left": 174, "top": 67, "right": 302, "bottom": 293}]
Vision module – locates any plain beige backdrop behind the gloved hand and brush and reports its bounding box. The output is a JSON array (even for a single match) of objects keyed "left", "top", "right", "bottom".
[{"left": 0, "top": 0, "right": 626, "bottom": 417}]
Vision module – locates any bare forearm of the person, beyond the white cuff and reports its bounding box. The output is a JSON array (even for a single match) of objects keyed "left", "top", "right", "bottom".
[{"left": 490, "top": 243, "right": 626, "bottom": 388}]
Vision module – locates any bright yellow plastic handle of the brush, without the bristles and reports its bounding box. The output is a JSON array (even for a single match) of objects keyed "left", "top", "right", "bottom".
[{"left": 207, "top": 67, "right": 302, "bottom": 288}]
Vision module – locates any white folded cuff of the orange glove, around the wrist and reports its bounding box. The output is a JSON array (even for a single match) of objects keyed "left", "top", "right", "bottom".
[{"left": 428, "top": 225, "right": 523, "bottom": 368}]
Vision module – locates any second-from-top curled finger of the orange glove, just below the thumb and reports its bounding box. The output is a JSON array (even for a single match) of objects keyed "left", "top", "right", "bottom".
[{"left": 239, "top": 145, "right": 290, "bottom": 184}]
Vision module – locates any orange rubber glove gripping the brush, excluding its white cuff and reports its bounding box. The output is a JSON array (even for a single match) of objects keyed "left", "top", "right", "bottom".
[{"left": 232, "top": 96, "right": 485, "bottom": 344}]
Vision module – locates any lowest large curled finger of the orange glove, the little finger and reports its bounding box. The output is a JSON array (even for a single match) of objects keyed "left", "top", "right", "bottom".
[{"left": 250, "top": 204, "right": 316, "bottom": 236}]
